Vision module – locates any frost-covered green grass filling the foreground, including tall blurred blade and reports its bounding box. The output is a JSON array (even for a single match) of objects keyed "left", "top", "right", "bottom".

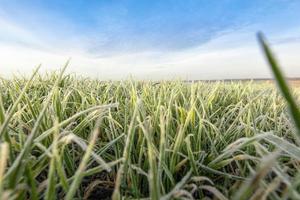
[{"left": 0, "top": 33, "right": 300, "bottom": 200}]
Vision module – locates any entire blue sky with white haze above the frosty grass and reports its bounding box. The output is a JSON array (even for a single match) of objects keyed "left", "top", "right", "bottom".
[{"left": 0, "top": 0, "right": 300, "bottom": 80}]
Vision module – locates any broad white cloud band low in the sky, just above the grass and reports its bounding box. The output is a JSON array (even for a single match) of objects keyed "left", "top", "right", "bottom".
[{"left": 0, "top": 19, "right": 300, "bottom": 79}]
